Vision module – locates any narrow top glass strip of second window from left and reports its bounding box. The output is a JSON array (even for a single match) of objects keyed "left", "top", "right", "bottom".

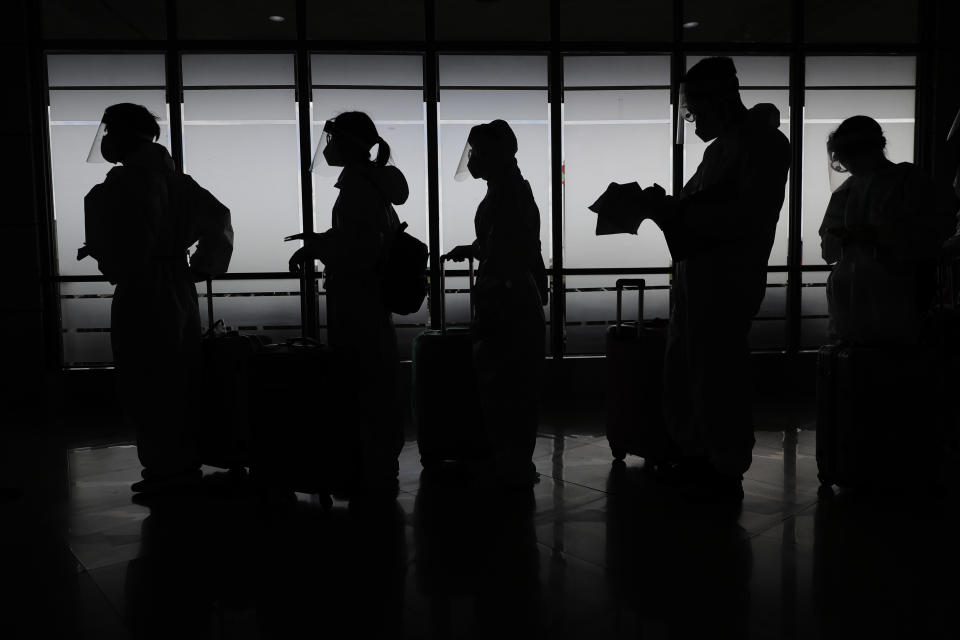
[{"left": 183, "top": 53, "right": 294, "bottom": 87}]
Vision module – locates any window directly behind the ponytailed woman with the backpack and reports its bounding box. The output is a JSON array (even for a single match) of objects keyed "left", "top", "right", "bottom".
[{"left": 310, "top": 54, "right": 428, "bottom": 357}]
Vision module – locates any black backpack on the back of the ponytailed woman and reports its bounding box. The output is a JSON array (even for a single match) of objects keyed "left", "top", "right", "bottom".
[{"left": 380, "top": 222, "right": 430, "bottom": 315}]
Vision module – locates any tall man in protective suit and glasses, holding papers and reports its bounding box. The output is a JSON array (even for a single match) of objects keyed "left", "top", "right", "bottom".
[{"left": 632, "top": 57, "right": 790, "bottom": 503}]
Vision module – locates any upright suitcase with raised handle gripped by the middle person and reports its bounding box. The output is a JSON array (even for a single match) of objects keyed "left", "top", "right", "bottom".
[{"left": 412, "top": 260, "right": 490, "bottom": 467}]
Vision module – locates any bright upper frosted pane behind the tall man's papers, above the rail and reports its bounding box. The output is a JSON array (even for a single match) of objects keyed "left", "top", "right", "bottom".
[{"left": 563, "top": 56, "right": 672, "bottom": 270}]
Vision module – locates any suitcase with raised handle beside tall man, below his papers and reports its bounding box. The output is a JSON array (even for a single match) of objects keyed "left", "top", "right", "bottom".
[{"left": 606, "top": 279, "right": 673, "bottom": 464}]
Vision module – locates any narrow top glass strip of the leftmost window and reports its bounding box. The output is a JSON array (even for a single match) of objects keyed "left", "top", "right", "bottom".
[{"left": 47, "top": 54, "right": 166, "bottom": 87}]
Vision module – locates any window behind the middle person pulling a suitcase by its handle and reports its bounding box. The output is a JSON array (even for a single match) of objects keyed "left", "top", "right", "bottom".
[{"left": 437, "top": 55, "right": 551, "bottom": 330}]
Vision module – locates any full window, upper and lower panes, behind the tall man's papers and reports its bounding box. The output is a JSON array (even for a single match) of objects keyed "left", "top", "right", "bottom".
[{"left": 562, "top": 56, "right": 673, "bottom": 354}]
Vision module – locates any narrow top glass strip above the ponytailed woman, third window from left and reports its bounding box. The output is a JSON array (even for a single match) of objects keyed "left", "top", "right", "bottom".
[{"left": 310, "top": 54, "right": 423, "bottom": 86}]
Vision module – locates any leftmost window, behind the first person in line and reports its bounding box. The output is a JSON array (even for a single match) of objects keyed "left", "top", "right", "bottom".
[{"left": 47, "top": 54, "right": 170, "bottom": 366}]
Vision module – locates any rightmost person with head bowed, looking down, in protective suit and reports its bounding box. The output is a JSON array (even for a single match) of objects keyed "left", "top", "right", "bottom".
[{"left": 820, "top": 116, "right": 957, "bottom": 344}]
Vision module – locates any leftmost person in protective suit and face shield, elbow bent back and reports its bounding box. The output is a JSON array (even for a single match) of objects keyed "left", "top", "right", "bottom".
[{"left": 78, "top": 103, "right": 233, "bottom": 492}]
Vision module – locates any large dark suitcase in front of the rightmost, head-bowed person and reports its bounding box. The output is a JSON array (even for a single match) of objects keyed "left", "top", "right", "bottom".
[{"left": 816, "top": 345, "right": 943, "bottom": 487}]
